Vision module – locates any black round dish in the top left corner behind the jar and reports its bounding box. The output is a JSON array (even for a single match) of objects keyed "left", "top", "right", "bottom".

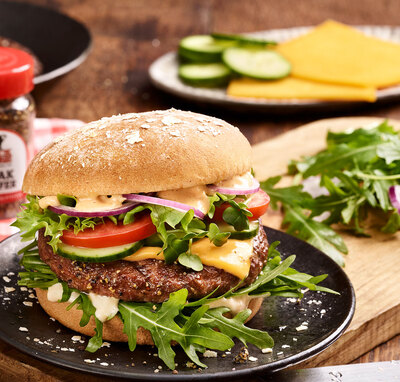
[{"left": 0, "top": 2, "right": 91, "bottom": 84}]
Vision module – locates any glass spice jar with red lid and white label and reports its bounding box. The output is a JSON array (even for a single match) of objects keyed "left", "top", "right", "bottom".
[{"left": 0, "top": 47, "right": 35, "bottom": 219}]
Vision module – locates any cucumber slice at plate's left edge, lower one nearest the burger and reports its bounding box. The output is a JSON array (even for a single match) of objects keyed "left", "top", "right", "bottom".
[{"left": 178, "top": 63, "right": 231, "bottom": 87}]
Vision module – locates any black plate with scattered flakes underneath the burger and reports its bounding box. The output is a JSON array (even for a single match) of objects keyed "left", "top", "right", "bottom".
[{"left": 0, "top": 228, "right": 355, "bottom": 380}]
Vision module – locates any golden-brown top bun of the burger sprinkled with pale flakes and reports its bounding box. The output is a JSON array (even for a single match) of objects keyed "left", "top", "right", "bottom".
[{"left": 22, "top": 109, "right": 251, "bottom": 197}]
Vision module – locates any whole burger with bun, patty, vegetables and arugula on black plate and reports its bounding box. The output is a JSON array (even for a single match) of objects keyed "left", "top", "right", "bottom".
[{"left": 14, "top": 109, "right": 334, "bottom": 369}]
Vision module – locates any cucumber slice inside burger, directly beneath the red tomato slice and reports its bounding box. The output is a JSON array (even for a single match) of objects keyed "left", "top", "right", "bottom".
[{"left": 57, "top": 241, "right": 143, "bottom": 263}]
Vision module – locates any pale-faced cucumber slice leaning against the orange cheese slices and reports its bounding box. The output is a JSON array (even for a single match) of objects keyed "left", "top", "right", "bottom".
[{"left": 222, "top": 47, "right": 291, "bottom": 80}]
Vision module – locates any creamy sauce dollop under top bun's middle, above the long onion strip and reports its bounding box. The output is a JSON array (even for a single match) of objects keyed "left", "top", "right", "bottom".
[{"left": 157, "top": 186, "right": 210, "bottom": 213}]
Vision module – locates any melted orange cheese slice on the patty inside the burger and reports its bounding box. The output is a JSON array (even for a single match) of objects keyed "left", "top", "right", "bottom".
[{"left": 124, "top": 238, "right": 253, "bottom": 279}]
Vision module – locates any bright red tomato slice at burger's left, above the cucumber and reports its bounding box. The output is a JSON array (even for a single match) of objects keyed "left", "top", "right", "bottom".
[{"left": 61, "top": 215, "right": 157, "bottom": 248}]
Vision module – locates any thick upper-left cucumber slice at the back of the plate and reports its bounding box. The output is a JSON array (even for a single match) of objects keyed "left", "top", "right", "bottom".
[{"left": 178, "top": 35, "right": 235, "bottom": 63}]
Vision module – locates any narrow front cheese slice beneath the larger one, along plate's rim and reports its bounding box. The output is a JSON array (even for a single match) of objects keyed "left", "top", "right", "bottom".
[{"left": 227, "top": 77, "right": 376, "bottom": 102}]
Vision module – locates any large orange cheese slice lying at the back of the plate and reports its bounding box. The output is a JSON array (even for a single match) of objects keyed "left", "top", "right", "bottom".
[{"left": 276, "top": 21, "right": 400, "bottom": 88}]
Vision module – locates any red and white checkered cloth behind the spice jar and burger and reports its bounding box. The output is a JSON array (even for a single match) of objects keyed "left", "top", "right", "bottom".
[{"left": 0, "top": 118, "right": 84, "bottom": 240}]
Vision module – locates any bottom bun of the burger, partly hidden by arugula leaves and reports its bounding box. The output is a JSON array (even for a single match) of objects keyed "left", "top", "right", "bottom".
[{"left": 35, "top": 288, "right": 263, "bottom": 345}]
